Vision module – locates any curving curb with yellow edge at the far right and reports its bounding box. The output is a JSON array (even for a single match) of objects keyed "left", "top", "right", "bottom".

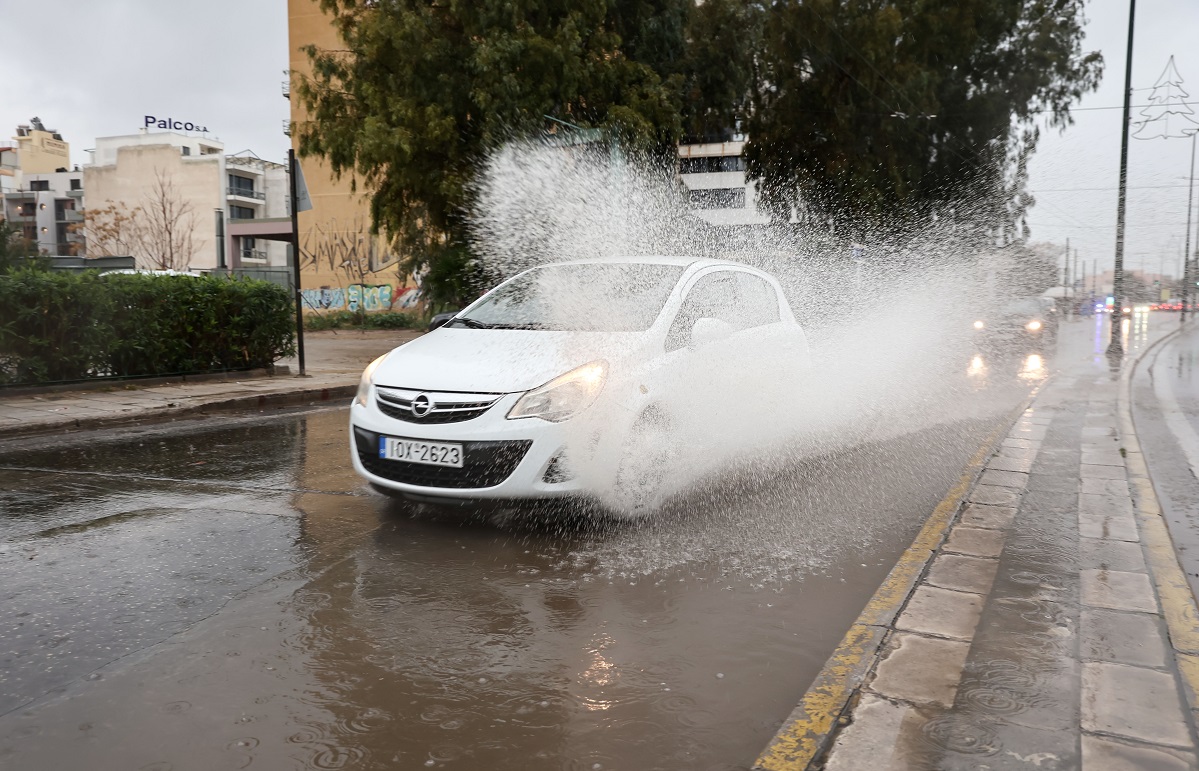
[{"left": 1116, "top": 326, "right": 1199, "bottom": 711}]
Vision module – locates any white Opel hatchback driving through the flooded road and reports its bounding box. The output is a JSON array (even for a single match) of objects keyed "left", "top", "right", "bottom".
[{"left": 350, "top": 258, "right": 808, "bottom": 512}]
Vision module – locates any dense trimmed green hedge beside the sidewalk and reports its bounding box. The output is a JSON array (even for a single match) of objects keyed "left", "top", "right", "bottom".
[{"left": 0, "top": 269, "right": 295, "bottom": 385}]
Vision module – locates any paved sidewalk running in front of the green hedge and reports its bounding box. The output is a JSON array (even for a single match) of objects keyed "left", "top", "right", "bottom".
[{"left": 0, "top": 330, "right": 418, "bottom": 441}]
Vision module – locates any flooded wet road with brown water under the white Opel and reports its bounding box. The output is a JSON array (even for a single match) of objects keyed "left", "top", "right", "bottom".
[{"left": 0, "top": 356, "right": 1044, "bottom": 771}]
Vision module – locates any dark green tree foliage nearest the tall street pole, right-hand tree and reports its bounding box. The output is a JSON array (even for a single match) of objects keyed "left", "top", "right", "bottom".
[{"left": 747, "top": 0, "right": 1102, "bottom": 242}]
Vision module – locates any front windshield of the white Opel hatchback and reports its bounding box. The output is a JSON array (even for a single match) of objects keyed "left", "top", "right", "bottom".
[{"left": 451, "top": 263, "right": 683, "bottom": 332}]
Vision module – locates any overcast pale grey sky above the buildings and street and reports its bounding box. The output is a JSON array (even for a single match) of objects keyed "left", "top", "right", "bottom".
[{"left": 0, "top": 0, "right": 1199, "bottom": 273}]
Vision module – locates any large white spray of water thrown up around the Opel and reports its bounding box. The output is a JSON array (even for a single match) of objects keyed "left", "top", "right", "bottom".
[{"left": 474, "top": 144, "right": 1050, "bottom": 553}]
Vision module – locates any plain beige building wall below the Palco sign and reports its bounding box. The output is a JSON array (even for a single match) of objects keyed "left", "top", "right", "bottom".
[{"left": 83, "top": 145, "right": 225, "bottom": 270}]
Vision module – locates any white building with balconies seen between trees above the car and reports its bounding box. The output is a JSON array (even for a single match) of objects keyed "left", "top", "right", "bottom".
[{"left": 679, "top": 140, "right": 770, "bottom": 225}]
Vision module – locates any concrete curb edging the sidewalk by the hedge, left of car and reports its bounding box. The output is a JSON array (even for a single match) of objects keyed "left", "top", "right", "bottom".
[{"left": 0, "top": 383, "right": 359, "bottom": 441}]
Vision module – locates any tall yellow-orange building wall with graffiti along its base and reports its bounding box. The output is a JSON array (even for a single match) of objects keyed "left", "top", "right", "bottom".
[{"left": 288, "top": 0, "right": 417, "bottom": 311}]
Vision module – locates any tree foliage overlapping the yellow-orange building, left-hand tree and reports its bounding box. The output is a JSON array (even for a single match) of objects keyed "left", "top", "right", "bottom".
[{"left": 296, "top": 0, "right": 691, "bottom": 303}]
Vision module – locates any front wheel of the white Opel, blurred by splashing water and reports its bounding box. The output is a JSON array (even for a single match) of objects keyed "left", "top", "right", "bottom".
[{"left": 613, "top": 406, "right": 676, "bottom": 519}]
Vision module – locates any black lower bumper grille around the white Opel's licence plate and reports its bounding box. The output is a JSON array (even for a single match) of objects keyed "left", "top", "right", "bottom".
[{"left": 354, "top": 426, "right": 532, "bottom": 489}]
